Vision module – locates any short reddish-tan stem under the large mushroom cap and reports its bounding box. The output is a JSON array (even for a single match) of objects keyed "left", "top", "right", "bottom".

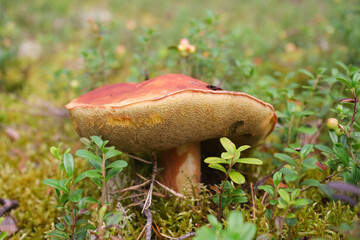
[{"left": 160, "top": 142, "right": 201, "bottom": 192}]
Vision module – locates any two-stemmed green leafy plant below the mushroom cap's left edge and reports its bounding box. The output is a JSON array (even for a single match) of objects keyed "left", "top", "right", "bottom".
[{"left": 43, "top": 136, "right": 127, "bottom": 239}]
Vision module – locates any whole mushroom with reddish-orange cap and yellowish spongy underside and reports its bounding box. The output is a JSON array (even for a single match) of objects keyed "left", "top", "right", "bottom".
[{"left": 66, "top": 74, "right": 277, "bottom": 191}]
